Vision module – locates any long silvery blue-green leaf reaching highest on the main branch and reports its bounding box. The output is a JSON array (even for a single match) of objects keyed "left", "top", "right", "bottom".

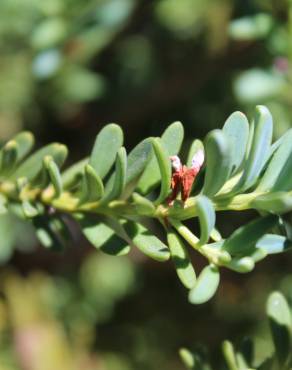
[{"left": 234, "top": 105, "right": 273, "bottom": 191}]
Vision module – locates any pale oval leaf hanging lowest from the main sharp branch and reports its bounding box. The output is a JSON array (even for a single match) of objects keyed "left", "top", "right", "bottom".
[{"left": 189, "top": 264, "right": 220, "bottom": 304}]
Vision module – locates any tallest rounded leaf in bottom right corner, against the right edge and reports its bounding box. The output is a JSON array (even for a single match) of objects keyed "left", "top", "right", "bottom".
[{"left": 267, "top": 292, "right": 291, "bottom": 368}]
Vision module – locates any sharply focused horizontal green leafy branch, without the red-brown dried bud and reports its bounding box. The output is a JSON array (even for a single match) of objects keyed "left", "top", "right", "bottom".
[{"left": 0, "top": 106, "right": 292, "bottom": 304}]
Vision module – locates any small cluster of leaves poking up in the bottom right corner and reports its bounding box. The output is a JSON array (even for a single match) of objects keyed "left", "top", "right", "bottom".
[{"left": 179, "top": 291, "right": 292, "bottom": 370}]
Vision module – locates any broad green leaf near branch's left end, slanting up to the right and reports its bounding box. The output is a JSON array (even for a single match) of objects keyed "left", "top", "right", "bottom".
[{"left": 10, "top": 143, "right": 68, "bottom": 180}]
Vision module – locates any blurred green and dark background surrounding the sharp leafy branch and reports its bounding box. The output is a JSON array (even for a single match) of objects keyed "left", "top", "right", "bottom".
[{"left": 0, "top": 0, "right": 292, "bottom": 370}]
